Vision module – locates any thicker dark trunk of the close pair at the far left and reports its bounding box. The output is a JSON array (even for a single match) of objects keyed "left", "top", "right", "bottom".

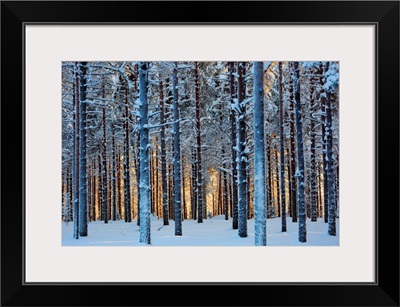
[{"left": 79, "top": 62, "right": 88, "bottom": 237}]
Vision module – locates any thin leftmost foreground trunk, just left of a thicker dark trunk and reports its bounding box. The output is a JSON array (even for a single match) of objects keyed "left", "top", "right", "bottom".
[{"left": 73, "top": 63, "right": 80, "bottom": 239}]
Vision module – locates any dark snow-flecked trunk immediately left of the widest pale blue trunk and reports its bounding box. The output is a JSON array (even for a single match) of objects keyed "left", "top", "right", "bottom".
[{"left": 237, "top": 62, "right": 247, "bottom": 238}]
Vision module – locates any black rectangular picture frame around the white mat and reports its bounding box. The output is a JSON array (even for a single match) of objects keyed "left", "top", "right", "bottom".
[{"left": 1, "top": 1, "right": 399, "bottom": 306}]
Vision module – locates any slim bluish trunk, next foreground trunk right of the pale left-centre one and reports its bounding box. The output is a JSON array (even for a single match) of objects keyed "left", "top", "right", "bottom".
[{"left": 172, "top": 62, "right": 184, "bottom": 236}]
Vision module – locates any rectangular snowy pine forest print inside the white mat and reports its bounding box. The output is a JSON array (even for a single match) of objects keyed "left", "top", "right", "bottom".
[{"left": 60, "top": 61, "right": 339, "bottom": 246}]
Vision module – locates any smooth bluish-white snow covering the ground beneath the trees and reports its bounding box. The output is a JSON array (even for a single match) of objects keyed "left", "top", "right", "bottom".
[{"left": 62, "top": 215, "right": 340, "bottom": 246}]
